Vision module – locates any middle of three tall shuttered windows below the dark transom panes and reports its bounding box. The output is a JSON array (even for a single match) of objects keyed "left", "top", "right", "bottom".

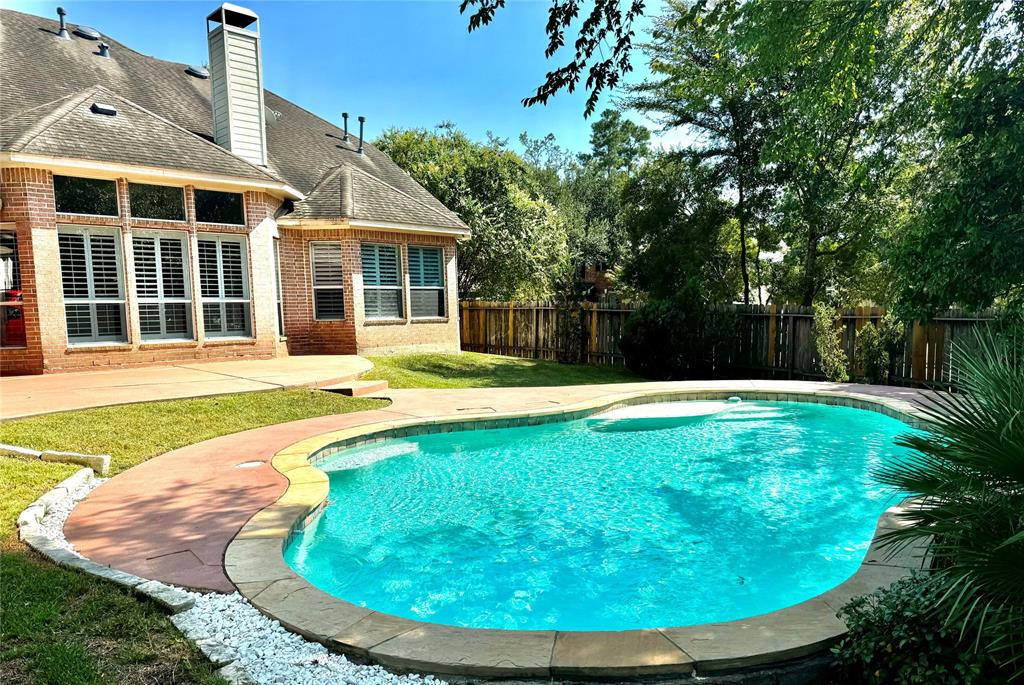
[{"left": 132, "top": 232, "right": 193, "bottom": 340}]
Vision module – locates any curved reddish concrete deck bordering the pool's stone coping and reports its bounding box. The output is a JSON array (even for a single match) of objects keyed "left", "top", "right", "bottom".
[{"left": 65, "top": 381, "right": 924, "bottom": 592}]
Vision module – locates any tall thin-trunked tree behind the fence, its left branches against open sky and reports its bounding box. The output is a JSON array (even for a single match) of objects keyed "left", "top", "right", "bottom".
[{"left": 628, "top": 0, "right": 781, "bottom": 304}]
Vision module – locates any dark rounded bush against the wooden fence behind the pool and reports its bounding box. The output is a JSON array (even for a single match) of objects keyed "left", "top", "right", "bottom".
[{"left": 618, "top": 297, "right": 736, "bottom": 380}]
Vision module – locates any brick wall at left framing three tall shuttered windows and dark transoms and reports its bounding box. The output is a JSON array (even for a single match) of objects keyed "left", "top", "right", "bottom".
[{"left": 0, "top": 168, "right": 283, "bottom": 374}]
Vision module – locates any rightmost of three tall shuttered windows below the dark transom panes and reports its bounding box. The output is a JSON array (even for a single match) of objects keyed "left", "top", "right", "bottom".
[{"left": 199, "top": 234, "right": 252, "bottom": 338}]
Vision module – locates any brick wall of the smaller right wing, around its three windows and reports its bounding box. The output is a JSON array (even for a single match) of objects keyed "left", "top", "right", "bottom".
[{"left": 279, "top": 225, "right": 459, "bottom": 354}]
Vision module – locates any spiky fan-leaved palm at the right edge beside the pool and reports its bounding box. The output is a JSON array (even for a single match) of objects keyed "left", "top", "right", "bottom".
[{"left": 877, "top": 333, "right": 1024, "bottom": 679}]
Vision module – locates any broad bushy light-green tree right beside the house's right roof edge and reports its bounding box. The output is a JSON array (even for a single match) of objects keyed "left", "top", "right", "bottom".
[{"left": 375, "top": 124, "right": 567, "bottom": 299}]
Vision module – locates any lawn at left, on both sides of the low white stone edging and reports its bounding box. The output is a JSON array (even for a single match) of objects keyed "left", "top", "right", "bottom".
[{"left": 0, "top": 389, "right": 384, "bottom": 685}]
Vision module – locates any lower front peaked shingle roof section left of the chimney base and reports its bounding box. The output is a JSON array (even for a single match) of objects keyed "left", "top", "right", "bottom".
[{"left": 0, "top": 86, "right": 281, "bottom": 181}]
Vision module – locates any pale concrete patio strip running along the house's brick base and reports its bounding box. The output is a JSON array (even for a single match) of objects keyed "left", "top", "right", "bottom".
[{"left": 0, "top": 354, "right": 373, "bottom": 419}]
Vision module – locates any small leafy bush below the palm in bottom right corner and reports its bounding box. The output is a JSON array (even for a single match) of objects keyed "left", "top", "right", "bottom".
[{"left": 833, "top": 576, "right": 1009, "bottom": 685}]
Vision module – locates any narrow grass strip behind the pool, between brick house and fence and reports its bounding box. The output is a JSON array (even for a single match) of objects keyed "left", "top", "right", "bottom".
[{"left": 362, "top": 352, "right": 643, "bottom": 388}]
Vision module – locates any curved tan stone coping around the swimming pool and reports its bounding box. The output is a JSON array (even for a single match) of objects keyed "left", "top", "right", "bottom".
[{"left": 224, "top": 386, "right": 924, "bottom": 680}]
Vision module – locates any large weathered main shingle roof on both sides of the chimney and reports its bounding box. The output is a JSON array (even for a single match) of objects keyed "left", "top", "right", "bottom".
[{"left": 0, "top": 9, "right": 466, "bottom": 229}]
